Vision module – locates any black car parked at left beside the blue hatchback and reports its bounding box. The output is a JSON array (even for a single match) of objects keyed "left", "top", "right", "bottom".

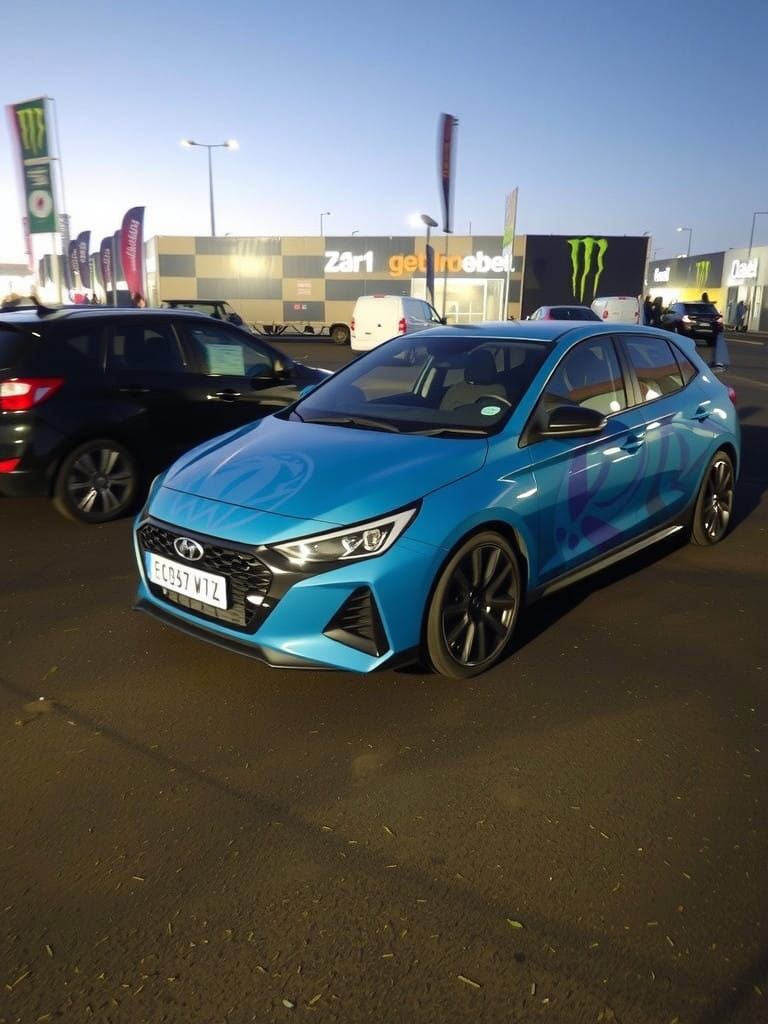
[{"left": 0, "top": 306, "right": 330, "bottom": 522}]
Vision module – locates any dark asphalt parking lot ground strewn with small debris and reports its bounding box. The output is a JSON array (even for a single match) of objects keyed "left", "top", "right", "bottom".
[{"left": 0, "top": 331, "right": 768, "bottom": 1024}]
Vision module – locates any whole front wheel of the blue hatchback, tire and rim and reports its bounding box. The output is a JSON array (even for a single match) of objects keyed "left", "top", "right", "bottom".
[{"left": 425, "top": 530, "right": 522, "bottom": 679}]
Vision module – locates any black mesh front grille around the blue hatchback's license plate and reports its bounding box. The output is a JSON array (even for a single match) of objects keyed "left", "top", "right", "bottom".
[{"left": 138, "top": 522, "right": 272, "bottom": 632}]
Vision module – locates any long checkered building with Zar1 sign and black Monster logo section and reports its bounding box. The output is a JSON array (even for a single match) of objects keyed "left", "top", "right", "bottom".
[{"left": 144, "top": 233, "right": 648, "bottom": 330}]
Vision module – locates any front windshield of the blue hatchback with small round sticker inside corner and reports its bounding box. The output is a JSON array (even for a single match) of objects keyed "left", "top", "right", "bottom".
[{"left": 285, "top": 332, "right": 548, "bottom": 437}]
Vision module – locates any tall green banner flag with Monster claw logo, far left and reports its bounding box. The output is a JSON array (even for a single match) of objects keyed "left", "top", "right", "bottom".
[{"left": 7, "top": 96, "right": 56, "bottom": 234}]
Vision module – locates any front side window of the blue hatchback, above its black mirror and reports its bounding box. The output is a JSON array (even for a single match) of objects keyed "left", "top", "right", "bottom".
[{"left": 544, "top": 338, "right": 627, "bottom": 416}]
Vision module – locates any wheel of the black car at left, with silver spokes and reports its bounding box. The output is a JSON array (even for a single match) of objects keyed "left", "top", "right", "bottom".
[{"left": 53, "top": 437, "right": 139, "bottom": 523}]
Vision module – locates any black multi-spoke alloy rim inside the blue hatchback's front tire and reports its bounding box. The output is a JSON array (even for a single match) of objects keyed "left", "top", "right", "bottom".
[{"left": 441, "top": 544, "right": 517, "bottom": 666}]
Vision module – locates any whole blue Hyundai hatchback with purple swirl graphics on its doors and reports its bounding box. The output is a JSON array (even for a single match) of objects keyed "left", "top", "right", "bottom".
[{"left": 135, "top": 322, "right": 739, "bottom": 678}]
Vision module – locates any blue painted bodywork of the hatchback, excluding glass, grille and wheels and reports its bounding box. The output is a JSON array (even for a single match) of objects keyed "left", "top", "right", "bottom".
[{"left": 136, "top": 325, "right": 739, "bottom": 672}]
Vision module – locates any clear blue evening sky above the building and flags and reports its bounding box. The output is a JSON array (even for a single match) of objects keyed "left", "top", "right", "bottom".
[{"left": 0, "top": 0, "right": 768, "bottom": 260}]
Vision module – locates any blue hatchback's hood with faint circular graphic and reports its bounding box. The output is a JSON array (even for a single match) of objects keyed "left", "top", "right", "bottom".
[{"left": 163, "top": 416, "right": 487, "bottom": 525}]
